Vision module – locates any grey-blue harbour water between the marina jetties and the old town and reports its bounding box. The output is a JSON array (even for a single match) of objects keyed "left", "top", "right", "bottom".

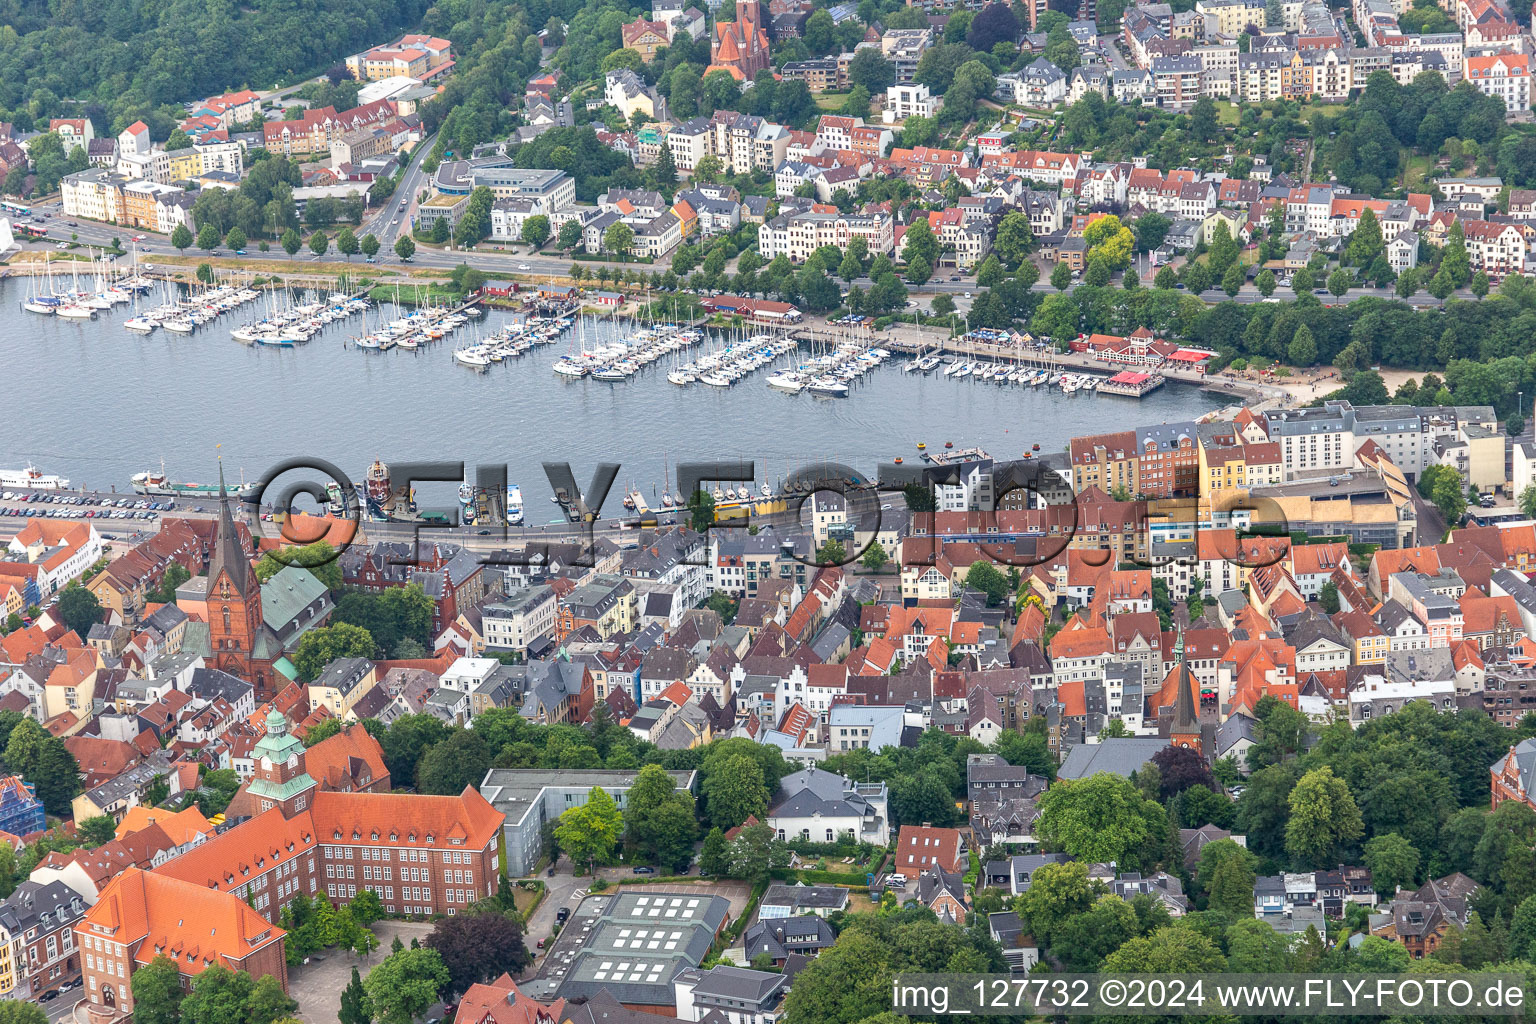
[{"left": 0, "top": 279, "right": 1224, "bottom": 524}]
